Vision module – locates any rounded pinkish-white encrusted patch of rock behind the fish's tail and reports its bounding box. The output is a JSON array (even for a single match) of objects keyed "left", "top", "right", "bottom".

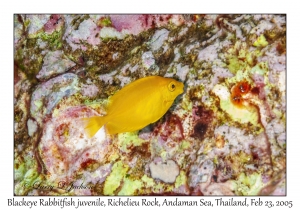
[{"left": 39, "top": 107, "right": 109, "bottom": 185}]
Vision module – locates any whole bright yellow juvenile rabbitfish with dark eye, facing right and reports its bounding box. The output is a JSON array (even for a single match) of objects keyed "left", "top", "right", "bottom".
[{"left": 84, "top": 76, "right": 184, "bottom": 137}]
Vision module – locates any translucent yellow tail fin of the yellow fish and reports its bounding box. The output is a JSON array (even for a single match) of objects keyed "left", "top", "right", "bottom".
[{"left": 82, "top": 116, "right": 105, "bottom": 138}]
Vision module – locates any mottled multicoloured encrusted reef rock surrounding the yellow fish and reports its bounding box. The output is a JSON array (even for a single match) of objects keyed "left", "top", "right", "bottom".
[{"left": 14, "top": 14, "right": 288, "bottom": 196}]
